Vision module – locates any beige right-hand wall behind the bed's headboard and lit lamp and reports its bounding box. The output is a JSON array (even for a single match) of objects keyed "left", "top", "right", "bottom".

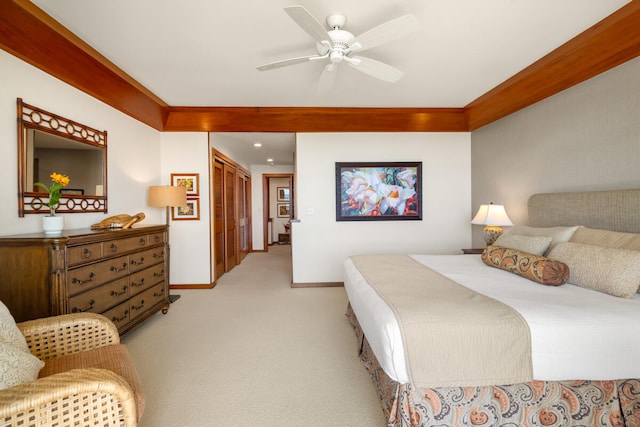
[{"left": 469, "top": 58, "right": 640, "bottom": 247}]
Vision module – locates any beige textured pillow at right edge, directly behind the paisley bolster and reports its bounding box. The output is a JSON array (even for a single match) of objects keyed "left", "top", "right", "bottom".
[{"left": 550, "top": 242, "right": 640, "bottom": 298}]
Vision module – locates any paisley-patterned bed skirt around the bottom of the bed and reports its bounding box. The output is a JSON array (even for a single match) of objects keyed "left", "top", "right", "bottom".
[{"left": 346, "top": 305, "right": 640, "bottom": 427}]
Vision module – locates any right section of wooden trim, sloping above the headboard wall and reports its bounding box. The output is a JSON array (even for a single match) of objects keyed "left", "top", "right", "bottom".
[{"left": 465, "top": 0, "right": 640, "bottom": 131}]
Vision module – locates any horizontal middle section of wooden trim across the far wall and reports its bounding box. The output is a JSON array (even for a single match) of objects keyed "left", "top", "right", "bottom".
[{"left": 165, "top": 107, "right": 468, "bottom": 132}]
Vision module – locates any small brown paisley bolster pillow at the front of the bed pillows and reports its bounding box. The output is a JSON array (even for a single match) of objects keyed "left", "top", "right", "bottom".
[{"left": 481, "top": 245, "right": 569, "bottom": 286}]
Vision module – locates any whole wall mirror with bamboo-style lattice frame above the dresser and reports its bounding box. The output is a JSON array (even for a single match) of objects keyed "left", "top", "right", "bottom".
[{"left": 18, "top": 98, "right": 107, "bottom": 217}]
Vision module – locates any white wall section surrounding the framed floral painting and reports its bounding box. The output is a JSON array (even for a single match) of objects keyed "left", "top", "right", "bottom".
[{"left": 291, "top": 132, "right": 471, "bottom": 283}]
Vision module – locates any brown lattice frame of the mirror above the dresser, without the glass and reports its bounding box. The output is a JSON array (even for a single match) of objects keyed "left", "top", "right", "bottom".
[{"left": 18, "top": 98, "right": 108, "bottom": 217}]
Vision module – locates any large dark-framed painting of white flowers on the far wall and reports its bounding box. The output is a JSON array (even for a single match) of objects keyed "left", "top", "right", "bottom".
[{"left": 336, "top": 162, "right": 422, "bottom": 221}]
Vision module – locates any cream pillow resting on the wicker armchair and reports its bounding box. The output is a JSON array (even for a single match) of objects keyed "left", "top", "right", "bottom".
[{"left": 0, "top": 302, "right": 44, "bottom": 390}]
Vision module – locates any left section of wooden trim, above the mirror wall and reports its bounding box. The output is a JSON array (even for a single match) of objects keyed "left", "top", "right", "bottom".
[{"left": 0, "top": 0, "right": 167, "bottom": 130}]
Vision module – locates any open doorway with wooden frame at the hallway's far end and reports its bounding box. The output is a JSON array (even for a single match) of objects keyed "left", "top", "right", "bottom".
[{"left": 262, "top": 173, "right": 295, "bottom": 251}]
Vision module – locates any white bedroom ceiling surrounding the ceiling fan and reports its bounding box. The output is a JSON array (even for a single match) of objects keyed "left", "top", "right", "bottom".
[{"left": 32, "top": 0, "right": 629, "bottom": 166}]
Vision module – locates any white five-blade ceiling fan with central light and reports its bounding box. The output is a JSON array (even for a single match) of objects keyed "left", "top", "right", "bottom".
[{"left": 256, "top": 6, "right": 420, "bottom": 92}]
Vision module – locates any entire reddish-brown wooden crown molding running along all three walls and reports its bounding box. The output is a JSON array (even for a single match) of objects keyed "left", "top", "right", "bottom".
[{"left": 0, "top": 0, "right": 640, "bottom": 132}]
